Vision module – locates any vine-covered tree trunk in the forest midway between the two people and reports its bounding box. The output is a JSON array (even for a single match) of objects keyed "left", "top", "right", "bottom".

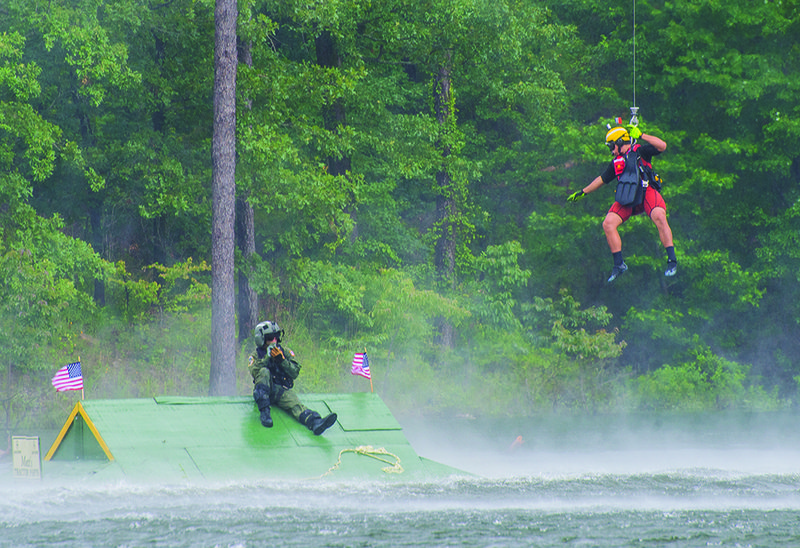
[{"left": 434, "top": 51, "right": 456, "bottom": 348}]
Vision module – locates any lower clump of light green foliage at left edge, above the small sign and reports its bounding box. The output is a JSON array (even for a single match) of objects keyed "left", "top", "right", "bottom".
[{"left": 0, "top": 206, "right": 103, "bottom": 428}]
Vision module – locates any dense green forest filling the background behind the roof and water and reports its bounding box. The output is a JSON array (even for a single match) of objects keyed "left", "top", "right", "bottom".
[{"left": 0, "top": 0, "right": 800, "bottom": 430}]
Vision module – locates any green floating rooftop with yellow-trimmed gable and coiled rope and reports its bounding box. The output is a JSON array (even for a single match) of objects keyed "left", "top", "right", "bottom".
[{"left": 42, "top": 393, "right": 466, "bottom": 482}]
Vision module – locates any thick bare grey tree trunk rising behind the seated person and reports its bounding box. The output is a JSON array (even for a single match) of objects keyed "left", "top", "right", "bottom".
[{"left": 209, "top": 0, "right": 237, "bottom": 396}]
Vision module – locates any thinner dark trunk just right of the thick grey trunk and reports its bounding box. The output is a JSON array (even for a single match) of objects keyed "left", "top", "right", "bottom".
[{"left": 236, "top": 36, "right": 258, "bottom": 342}]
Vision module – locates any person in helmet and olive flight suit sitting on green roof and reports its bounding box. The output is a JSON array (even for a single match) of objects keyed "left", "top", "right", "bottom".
[{"left": 248, "top": 321, "right": 337, "bottom": 436}]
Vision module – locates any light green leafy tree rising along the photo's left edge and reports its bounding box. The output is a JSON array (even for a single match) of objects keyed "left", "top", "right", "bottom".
[{"left": 0, "top": 28, "right": 108, "bottom": 429}]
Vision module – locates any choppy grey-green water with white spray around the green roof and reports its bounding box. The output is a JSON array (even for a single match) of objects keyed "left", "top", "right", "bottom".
[{"left": 0, "top": 415, "right": 800, "bottom": 547}]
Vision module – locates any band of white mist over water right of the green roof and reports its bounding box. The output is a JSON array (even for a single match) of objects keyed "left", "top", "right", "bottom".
[{"left": 401, "top": 412, "right": 800, "bottom": 478}]
